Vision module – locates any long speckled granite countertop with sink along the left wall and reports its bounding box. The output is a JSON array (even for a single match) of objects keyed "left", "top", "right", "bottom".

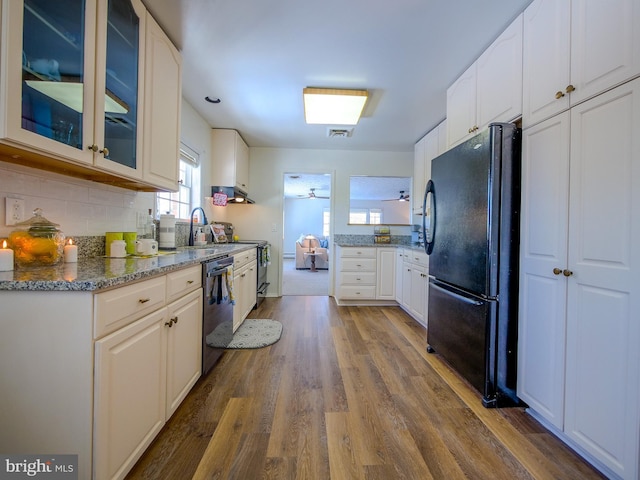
[{"left": 0, "top": 243, "right": 257, "bottom": 291}]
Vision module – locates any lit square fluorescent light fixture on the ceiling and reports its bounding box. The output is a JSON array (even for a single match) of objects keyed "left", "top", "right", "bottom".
[{"left": 302, "top": 87, "right": 369, "bottom": 125}]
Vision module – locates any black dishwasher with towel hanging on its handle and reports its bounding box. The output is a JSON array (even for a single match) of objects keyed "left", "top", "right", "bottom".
[{"left": 202, "top": 255, "right": 233, "bottom": 375}]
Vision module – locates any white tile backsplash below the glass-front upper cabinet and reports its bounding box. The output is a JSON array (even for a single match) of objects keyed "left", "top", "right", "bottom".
[{"left": 0, "top": 161, "right": 155, "bottom": 237}]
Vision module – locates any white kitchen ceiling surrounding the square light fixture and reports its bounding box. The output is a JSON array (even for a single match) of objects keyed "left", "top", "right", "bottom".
[{"left": 143, "top": 0, "right": 531, "bottom": 151}]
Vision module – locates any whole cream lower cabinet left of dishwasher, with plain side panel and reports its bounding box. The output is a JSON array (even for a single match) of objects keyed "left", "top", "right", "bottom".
[{"left": 0, "top": 264, "right": 202, "bottom": 480}]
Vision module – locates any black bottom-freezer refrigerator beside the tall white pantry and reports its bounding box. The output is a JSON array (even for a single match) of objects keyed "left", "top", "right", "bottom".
[{"left": 423, "top": 123, "right": 521, "bottom": 407}]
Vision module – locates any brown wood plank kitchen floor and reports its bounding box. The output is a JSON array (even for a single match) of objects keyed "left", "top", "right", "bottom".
[{"left": 127, "top": 296, "right": 604, "bottom": 480}]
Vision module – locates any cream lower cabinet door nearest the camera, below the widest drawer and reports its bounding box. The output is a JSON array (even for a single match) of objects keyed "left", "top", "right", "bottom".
[{"left": 94, "top": 307, "right": 168, "bottom": 479}]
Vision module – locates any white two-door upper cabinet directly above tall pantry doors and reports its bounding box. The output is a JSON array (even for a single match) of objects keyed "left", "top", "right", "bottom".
[{"left": 522, "top": 0, "right": 640, "bottom": 128}]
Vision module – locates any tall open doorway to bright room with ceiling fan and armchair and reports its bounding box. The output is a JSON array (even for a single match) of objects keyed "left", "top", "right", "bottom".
[{"left": 281, "top": 172, "right": 332, "bottom": 296}]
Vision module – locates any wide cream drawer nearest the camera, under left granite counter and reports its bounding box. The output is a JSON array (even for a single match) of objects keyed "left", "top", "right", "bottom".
[{"left": 94, "top": 276, "right": 166, "bottom": 338}]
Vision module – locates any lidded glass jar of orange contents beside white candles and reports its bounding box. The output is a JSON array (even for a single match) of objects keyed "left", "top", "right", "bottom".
[{"left": 8, "top": 208, "right": 65, "bottom": 268}]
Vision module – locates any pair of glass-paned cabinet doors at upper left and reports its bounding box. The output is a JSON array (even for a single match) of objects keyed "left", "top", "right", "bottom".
[{"left": 0, "top": 0, "right": 145, "bottom": 178}]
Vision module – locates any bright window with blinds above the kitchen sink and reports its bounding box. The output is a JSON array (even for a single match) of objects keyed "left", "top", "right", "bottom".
[{"left": 156, "top": 143, "right": 200, "bottom": 221}]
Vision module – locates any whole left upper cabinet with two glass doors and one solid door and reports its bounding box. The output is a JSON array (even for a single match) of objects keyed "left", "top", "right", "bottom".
[{"left": 0, "top": 0, "right": 181, "bottom": 190}]
